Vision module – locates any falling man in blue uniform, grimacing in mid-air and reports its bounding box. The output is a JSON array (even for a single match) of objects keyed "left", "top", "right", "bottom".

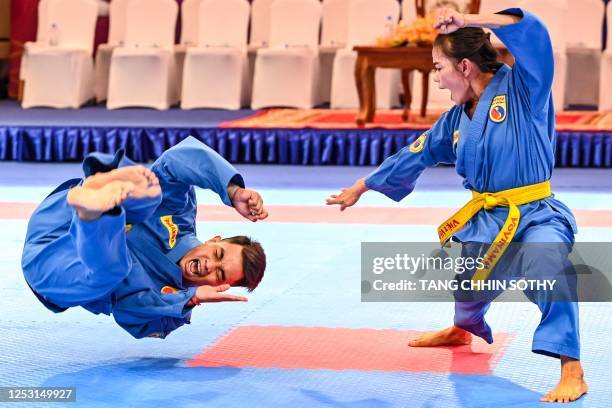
[{"left": 22, "top": 137, "right": 268, "bottom": 338}]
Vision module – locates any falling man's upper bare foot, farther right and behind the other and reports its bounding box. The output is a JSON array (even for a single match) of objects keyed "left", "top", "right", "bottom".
[{"left": 83, "top": 166, "right": 161, "bottom": 198}]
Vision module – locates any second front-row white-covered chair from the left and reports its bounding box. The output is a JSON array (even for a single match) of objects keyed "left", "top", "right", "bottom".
[{"left": 106, "top": 0, "right": 178, "bottom": 110}]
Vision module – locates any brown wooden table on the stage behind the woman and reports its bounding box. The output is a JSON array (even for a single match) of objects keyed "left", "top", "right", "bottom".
[{"left": 353, "top": 46, "right": 514, "bottom": 126}]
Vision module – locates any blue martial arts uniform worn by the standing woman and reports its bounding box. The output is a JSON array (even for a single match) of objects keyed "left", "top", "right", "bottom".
[{"left": 365, "top": 8, "right": 580, "bottom": 358}]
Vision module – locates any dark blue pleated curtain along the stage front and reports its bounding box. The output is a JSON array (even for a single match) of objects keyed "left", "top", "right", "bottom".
[{"left": 0, "top": 126, "right": 612, "bottom": 168}]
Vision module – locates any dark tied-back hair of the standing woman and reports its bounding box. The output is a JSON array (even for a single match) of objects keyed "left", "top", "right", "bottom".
[{"left": 434, "top": 27, "right": 503, "bottom": 73}]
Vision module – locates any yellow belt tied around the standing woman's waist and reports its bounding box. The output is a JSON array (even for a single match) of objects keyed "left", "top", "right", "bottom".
[{"left": 438, "top": 181, "right": 552, "bottom": 281}]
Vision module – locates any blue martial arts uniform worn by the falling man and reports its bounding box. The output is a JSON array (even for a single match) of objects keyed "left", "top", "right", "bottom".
[{"left": 22, "top": 137, "right": 244, "bottom": 338}]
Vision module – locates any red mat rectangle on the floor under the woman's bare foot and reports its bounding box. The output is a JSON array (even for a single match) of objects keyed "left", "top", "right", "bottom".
[{"left": 187, "top": 326, "right": 511, "bottom": 374}]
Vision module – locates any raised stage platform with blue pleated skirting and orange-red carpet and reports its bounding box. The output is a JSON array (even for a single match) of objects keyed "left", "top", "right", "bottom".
[{"left": 0, "top": 101, "right": 612, "bottom": 168}]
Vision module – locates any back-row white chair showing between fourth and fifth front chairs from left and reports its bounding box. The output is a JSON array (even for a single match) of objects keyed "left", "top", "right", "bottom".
[{"left": 319, "top": 0, "right": 351, "bottom": 102}]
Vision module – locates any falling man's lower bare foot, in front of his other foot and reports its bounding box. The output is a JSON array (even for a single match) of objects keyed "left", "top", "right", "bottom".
[{"left": 66, "top": 181, "right": 134, "bottom": 221}]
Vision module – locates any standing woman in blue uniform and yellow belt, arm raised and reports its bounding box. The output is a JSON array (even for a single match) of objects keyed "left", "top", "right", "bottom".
[{"left": 327, "top": 8, "right": 588, "bottom": 402}]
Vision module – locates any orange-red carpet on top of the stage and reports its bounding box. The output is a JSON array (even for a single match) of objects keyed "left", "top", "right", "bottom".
[{"left": 220, "top": 109, "right": 612, "bottom": 131}]
